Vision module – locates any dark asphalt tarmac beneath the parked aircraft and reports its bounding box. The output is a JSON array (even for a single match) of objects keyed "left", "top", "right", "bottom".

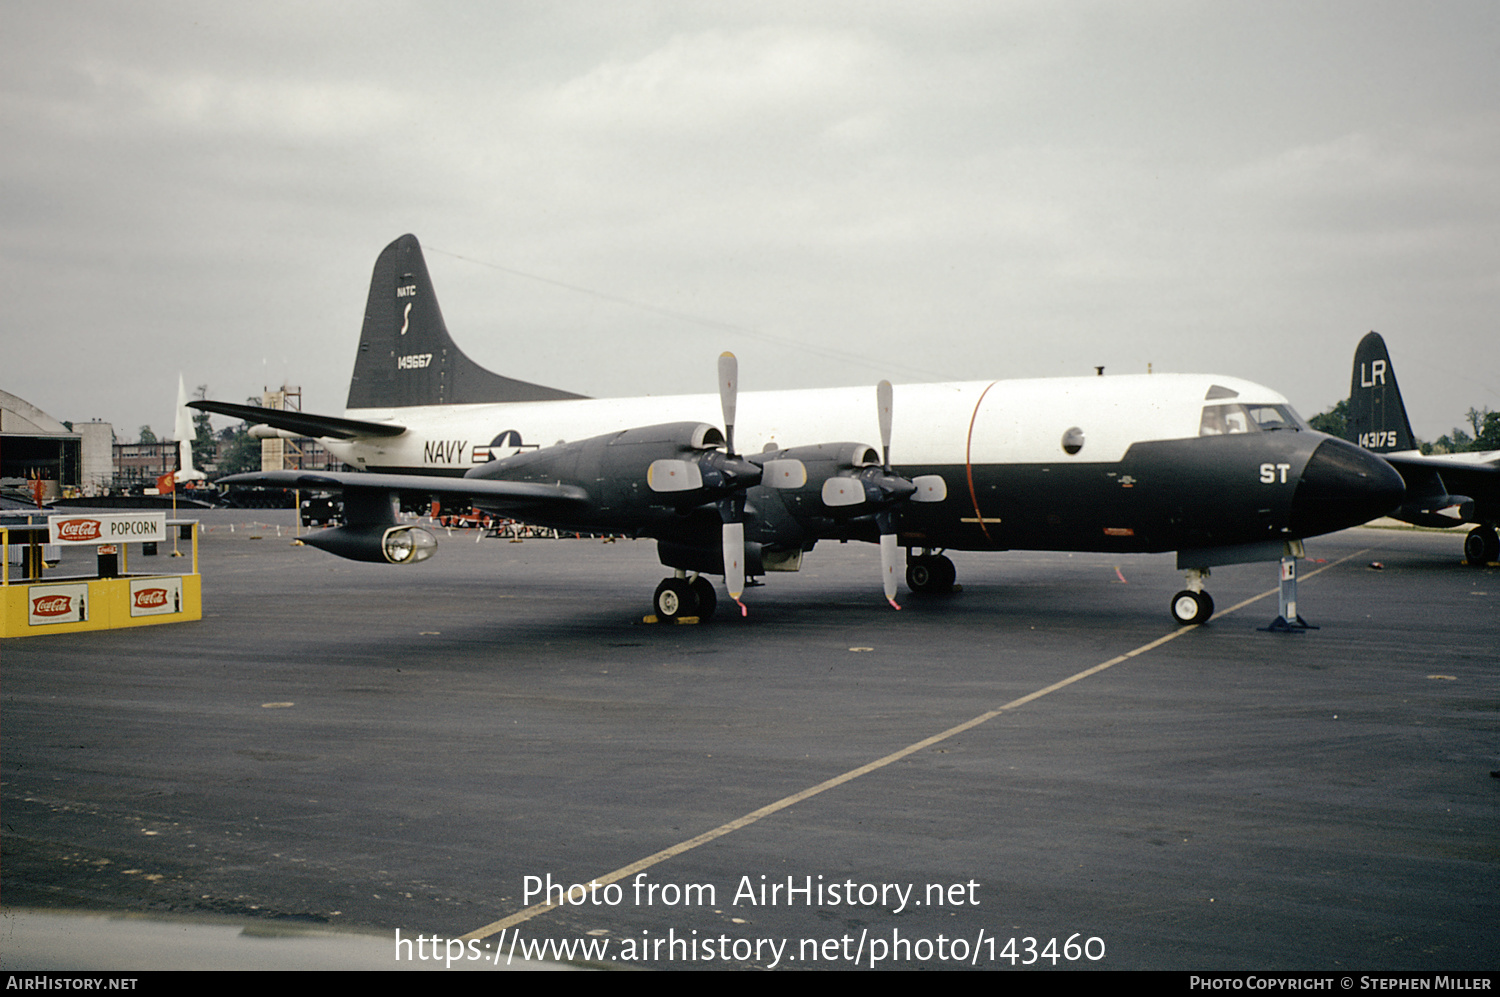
[{"left": 0, "top": 511, "right": 1500, "bottom": 970}]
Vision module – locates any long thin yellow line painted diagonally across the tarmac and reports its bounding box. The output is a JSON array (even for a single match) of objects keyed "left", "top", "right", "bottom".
[{"left": 461, "top": 549, "right": 1368, "bottom": 942}]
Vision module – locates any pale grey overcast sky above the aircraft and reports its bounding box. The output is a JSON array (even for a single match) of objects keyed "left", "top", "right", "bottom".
[{"left": 0, "top": 0, "right": 1500, "bottom": 442}]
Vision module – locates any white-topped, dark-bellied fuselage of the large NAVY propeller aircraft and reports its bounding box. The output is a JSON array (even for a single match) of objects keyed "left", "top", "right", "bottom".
[{"left": 329, "top": 375, "right": 1391, "bottom": 552}]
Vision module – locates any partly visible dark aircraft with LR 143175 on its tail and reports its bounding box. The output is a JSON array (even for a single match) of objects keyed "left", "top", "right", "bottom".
[{"left": 1346, "top": 333, "right": 1500, "bottom": 565}]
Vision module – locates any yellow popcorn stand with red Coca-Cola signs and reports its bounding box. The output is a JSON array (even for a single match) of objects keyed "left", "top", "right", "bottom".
[{"left": 0, "top": 511, "right": 203, "bottom": 637}]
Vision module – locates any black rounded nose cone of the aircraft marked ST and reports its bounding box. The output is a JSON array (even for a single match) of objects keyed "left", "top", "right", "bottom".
[{"left": 1290, "top": 438, "right": 1406, "bottom": 537}]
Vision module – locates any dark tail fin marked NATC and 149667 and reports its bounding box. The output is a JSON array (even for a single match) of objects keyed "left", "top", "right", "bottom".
[{"left": 348, "top": 235, "right": 584, "bottom": 409}]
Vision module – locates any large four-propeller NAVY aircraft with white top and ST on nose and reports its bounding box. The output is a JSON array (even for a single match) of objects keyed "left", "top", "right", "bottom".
[{"left": 192, "top": 235, "right": 1404, "bottom": 624}]
